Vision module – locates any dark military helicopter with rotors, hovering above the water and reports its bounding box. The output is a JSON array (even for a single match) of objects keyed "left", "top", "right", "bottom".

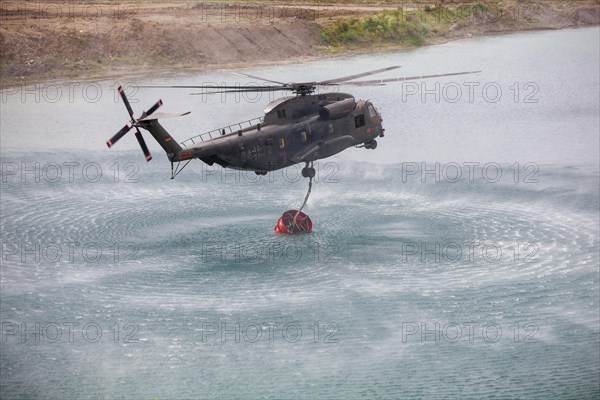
[{"left": 106, "top": 66, "right": 480, "bottom": 179}]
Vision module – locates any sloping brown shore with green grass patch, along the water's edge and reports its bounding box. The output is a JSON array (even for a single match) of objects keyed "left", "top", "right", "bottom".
[{"left": 0, "top": 0, "right": 600, "bottom": 89}]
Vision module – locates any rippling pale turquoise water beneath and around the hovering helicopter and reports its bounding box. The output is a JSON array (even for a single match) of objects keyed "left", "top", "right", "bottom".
[{"left": 0, "top": 28, "right": 600, "bottom": 399}]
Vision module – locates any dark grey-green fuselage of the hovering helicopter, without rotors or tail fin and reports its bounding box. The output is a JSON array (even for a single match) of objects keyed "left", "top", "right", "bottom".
[{"left": 165, "top": 93, "right": 384, "bottom": 174}]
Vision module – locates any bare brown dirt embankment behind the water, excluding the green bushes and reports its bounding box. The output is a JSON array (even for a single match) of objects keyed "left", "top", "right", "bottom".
[{"left": 0, "top": 0, "right": 600, "bottom": 87}]
